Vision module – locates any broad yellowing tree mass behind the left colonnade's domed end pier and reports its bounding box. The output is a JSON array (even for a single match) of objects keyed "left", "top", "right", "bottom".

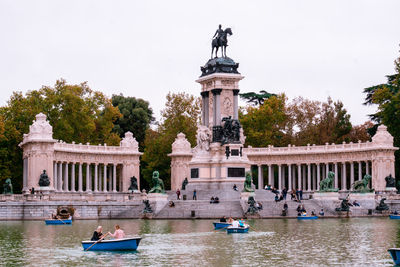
[{"left": 0, "top": 79, "right": 121, "bottom": 192}]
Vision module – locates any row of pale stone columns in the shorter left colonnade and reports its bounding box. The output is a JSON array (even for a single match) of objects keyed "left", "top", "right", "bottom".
[{"left": 53, "top": 161, "right": 122, "bottom": 193}]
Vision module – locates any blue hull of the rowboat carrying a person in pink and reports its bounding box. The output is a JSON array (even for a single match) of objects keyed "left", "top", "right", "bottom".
[{"left": 82, "top": 237, "right": 142, "bottom": 251}]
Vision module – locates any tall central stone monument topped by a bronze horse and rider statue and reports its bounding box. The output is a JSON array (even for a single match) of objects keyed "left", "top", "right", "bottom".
[{"left": 169, "top": 26, "right": 250, "bottom": 193}]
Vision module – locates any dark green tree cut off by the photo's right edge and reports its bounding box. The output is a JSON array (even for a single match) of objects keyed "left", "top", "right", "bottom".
[{"left": 364, "top": 48, "right": 400, "bottom": 177}]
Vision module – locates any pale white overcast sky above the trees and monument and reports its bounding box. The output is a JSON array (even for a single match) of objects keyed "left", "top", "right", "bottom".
[{"left": 0, "top": 0, "right": 400, "bottom": 124}]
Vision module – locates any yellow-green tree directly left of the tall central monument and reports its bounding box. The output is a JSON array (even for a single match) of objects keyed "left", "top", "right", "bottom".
[{"left": 142, "top": 93, "right": 201, "bottom": 191}]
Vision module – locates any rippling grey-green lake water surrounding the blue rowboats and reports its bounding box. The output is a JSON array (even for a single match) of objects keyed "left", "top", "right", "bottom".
[{"left": 0, "top": 218, "right": 400, "bottom": 266}]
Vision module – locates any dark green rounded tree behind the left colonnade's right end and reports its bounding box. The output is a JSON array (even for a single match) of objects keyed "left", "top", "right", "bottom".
[{"left": 111, "top": 94, "right": 154, "bottom": 151}]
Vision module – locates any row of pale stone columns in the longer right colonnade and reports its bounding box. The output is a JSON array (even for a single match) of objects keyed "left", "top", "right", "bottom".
[{"left": 256, "top": 160, "right": 372, "bottom": 192}]
